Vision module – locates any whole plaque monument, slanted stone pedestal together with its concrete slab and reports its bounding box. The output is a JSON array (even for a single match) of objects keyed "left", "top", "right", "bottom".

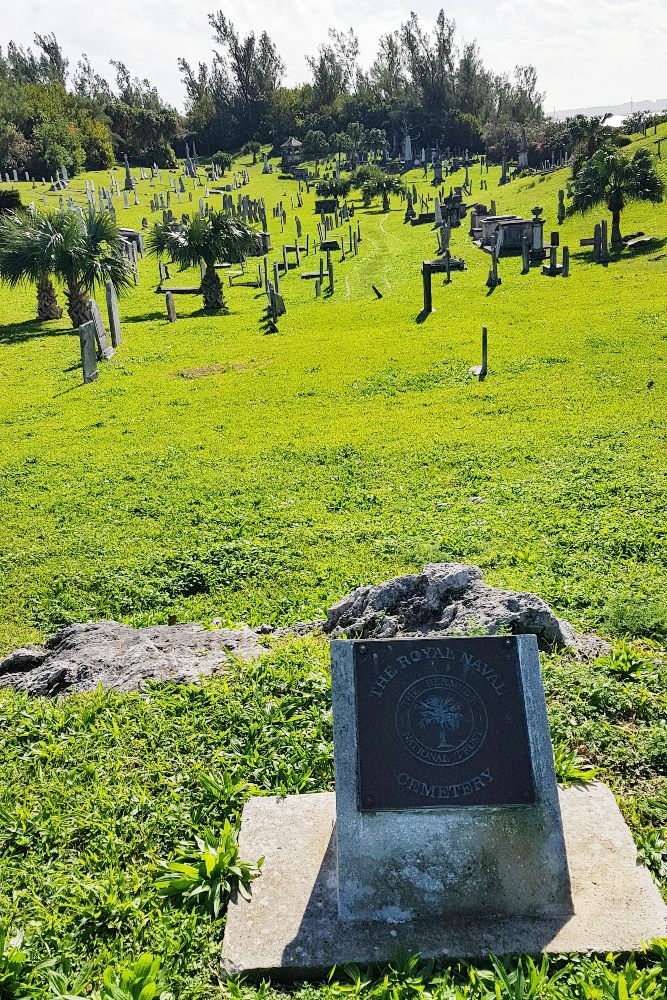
[{"left": 222, "top": 636, "right": 667, "bottom": 978}]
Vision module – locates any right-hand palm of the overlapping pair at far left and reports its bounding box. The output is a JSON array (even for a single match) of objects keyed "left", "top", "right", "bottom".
[{"left": 53, "top": 209, "right": 132, "bottom": 329}]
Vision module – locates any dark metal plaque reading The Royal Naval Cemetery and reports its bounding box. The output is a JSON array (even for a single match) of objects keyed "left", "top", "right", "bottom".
[{"left": 354, "top": 636, "right": 535, "bottom": 812}]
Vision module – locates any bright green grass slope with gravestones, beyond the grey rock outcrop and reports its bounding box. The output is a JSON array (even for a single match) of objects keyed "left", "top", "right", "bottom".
[{"left": 0, "top": 126, "right": 667, "bottom": 649}]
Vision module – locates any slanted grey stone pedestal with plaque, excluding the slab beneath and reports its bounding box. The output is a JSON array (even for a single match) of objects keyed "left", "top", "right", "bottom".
[{"left": 331, "top": 635, "right": 572, "bottom": 921}]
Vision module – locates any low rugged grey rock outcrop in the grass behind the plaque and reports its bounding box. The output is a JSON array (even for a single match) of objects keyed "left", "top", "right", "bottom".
[{"left": 0, "top": 563, "right": 609, "bottom": 695}]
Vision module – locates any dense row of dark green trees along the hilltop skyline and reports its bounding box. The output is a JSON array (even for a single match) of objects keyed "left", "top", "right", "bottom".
[{"left": 0, "top": 10, "right": 664, "bottom": 176}]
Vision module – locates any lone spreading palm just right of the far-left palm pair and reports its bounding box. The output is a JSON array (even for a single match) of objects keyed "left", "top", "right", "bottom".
[{"left": 146, "top": 212, "right": 259, "bottom": 310}]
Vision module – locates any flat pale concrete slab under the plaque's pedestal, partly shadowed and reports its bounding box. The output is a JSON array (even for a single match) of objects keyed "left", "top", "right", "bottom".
[{"left": 222, "top": 784, "right": 667, "bottom": 980}]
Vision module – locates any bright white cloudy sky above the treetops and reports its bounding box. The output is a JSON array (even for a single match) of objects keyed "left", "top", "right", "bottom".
[{"left": 0, "top": 0, "right": 667, "bottom": 113}]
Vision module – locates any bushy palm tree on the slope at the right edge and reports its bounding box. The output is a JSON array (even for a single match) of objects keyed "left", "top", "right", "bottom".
[{"left": 572, "top": 146, "right": 664, "bottom": 246}]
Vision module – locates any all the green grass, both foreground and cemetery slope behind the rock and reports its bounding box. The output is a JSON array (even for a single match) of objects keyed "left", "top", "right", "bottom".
[{"left": 0, "top": 126, "right": 667, "bottom": 1000}]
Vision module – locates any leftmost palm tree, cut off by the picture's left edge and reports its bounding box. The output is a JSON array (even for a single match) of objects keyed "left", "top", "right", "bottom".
[{"left": 0, "top": 212, "right": 63, "bottom": 322}]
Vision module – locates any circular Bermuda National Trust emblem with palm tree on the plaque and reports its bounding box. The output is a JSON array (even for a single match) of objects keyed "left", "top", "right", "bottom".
[{"left": 396, "top": 674, "right": 488, "bottom": 767}]
